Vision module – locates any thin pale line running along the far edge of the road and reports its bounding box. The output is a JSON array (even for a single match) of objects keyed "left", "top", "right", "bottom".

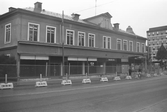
[{"left": 0, "top": 77, "right": 167, "bottom": 98}]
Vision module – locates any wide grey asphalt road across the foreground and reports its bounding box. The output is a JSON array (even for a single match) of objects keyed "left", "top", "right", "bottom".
[{"left": 0, "top": 76, "right": 167, "bottom": 112}]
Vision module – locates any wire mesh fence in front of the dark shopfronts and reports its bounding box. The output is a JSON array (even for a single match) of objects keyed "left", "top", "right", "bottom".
[{"left": 0, "top": 64, "right": 160, "bottom": 81}]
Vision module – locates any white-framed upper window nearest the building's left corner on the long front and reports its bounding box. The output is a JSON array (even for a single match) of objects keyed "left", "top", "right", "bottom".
[{"left": 28, "top": 23, "right": 39, "bottom": 41}]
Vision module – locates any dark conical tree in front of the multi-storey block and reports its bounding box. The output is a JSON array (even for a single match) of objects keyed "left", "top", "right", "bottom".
[{"left": 155, "top": 44, "right": 167, "bottom": 67}]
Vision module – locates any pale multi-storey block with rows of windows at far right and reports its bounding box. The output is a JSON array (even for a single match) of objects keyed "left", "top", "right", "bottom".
[{"left": 147, "top": 26, "right": 167, "bottom": 61}]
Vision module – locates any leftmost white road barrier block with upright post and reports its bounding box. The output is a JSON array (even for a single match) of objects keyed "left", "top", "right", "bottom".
[{"left": 0, "top": 74, "right": 14, "bottom": 89}]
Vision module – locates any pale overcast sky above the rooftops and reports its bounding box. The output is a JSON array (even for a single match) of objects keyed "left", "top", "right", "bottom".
[{"left": 0, "top": 0, "right": 167, "bottom": 37}]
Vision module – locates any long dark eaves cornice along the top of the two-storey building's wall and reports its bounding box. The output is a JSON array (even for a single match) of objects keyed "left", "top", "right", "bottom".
[{"left": 0, "top": 8, "right": 146, "bottom": 40}]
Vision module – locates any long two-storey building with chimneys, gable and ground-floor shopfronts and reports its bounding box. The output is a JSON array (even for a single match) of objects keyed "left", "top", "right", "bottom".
[{"left": 0, "top": 2, "right": 146, "bottom": 78}]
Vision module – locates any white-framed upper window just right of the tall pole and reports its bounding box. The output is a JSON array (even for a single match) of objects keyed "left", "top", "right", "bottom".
[{"left": 66, "top": 30, "right": 74, "bottom": 45}]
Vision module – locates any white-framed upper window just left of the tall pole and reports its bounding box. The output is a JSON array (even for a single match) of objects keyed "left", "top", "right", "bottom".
[{"left": 46, "top": 26, "right": 56, "bottom": 43}]
